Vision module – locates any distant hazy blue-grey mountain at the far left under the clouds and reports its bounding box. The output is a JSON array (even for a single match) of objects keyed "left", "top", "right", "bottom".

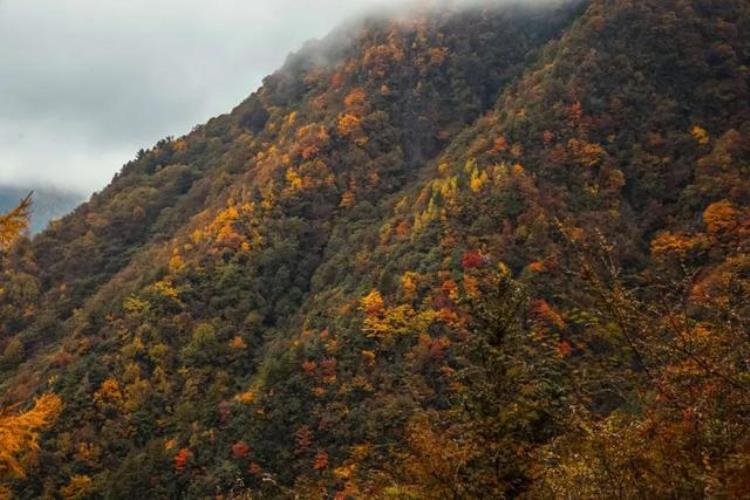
[{"left": 0, "top": 186, "right": 85, "bottom": 234}]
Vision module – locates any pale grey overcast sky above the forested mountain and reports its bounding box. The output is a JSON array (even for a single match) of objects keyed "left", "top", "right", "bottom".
[{"left": 0, "top": 0, "right": 412, "bottom": 192}]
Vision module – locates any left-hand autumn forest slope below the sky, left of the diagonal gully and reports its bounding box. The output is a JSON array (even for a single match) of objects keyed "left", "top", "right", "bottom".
[{"left": 2, "top": 1, "right": 588, "bottom": 497}]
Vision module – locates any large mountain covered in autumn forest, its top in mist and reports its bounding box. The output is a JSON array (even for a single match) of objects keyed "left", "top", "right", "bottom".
[{"left": 0, "top": 0, "right": 750, "bottom": 498}]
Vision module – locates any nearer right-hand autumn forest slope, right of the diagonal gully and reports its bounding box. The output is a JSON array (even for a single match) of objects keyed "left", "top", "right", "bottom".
[{"left": 244, "top": 1, "right": 749, "bottom": 497}]
